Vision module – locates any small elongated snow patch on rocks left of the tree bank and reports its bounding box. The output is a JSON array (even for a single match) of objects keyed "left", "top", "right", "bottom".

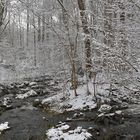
[{"left": 16, "top": 90, "right": 37, "bottom": 99}]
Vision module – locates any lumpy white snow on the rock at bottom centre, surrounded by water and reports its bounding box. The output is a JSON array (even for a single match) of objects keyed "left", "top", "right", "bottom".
[{"left": 46, "top": 125, "right": 92, "bottom": 140}]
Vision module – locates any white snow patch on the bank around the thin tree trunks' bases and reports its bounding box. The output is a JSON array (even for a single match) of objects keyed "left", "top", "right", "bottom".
[{"left": 42, "top": 85, "right": 96, "bottom": 111}]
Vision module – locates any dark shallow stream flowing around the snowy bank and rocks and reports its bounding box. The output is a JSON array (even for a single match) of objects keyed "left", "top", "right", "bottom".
[{"left": 0, "top": 77, "right": 140, "bottom": 140}]
